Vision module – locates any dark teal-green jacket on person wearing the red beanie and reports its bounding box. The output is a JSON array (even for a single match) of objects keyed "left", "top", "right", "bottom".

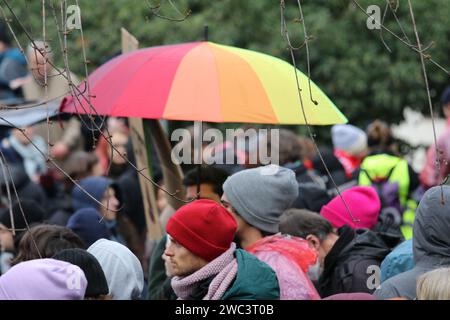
[{"left": 222, "top": 249, "right": 280, "bottom": 300}]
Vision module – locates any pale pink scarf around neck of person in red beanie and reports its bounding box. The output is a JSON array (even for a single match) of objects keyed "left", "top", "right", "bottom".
[{"left": 171, "top": 243, "right": 237, "bottom": 300}]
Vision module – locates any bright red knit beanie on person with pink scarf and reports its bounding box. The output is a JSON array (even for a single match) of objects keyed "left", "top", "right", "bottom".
[{"left": 166, "top": 199, "right": 237, "bottom": 261}]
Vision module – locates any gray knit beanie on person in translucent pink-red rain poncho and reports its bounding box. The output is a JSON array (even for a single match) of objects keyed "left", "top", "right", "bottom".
[{"left": 223, "top": 165, "right": 298, "bottom": 233}]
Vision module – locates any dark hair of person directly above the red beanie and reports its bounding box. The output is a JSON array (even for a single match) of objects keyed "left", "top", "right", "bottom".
[{"left": 183, "top": 166, "right": 228, "bottom": 196}]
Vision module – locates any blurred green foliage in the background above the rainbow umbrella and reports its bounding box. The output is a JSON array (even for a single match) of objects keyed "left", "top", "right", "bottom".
[{"left": 2, "top": 0, "right": 450, "bottom": 127}]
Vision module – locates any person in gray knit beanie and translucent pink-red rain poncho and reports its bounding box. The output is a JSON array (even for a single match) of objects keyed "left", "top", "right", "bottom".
[{"left": 222, "top": 165, "right": 320, "bottom": 300}]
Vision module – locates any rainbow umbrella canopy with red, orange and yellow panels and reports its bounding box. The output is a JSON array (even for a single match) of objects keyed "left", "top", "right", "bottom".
[{"left": 61, "top": 42, "right": 347, "bottom": 125}]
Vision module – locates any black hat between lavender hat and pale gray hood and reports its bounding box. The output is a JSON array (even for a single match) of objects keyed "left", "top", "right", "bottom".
[{"left": 53, "top": 248, "right": 109, "bottom": 298}]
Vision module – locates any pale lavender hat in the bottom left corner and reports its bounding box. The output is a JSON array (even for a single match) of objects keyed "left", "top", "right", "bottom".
[{"left": 0, "top": 259, "right": 87, "bottom": 300}]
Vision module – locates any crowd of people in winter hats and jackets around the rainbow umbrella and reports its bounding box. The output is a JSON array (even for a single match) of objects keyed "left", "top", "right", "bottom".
[{"left": 0, "top": 21, "right": 450, "bottom": 300}]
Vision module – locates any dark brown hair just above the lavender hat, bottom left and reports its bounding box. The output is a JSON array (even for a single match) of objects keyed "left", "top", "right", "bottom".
[{"left": 12, "top": 224, "right": 85, "bottom": 264}]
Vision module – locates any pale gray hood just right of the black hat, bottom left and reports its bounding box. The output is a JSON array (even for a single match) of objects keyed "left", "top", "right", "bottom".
[{"left": 87, "top": 239, "right": 144, "bottom": 300}]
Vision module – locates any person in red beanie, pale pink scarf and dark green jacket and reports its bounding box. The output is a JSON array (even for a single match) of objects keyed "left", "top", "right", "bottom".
[{"left": 164, "top": 199, "right": 279, "bottom": 300}]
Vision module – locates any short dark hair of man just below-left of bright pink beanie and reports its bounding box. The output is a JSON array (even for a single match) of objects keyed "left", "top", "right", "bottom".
[{"left": 280, "top": 209, "right": 333, "bottom": 240}]
